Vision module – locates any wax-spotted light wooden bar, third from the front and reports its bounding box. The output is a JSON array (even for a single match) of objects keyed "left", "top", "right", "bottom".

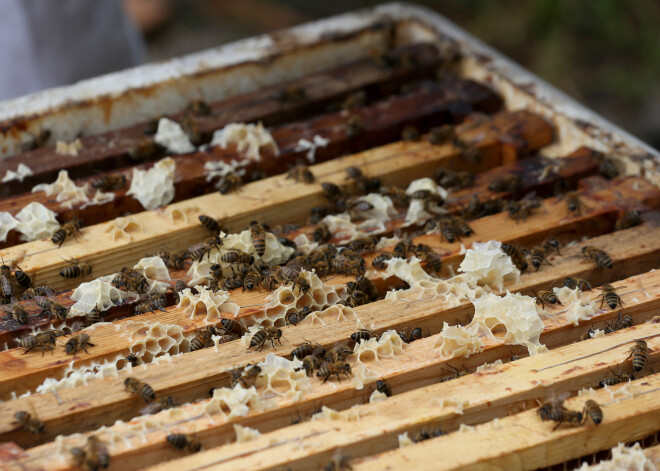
[{"left": 11, "top": 272, "right": 660, "bottom": 469}]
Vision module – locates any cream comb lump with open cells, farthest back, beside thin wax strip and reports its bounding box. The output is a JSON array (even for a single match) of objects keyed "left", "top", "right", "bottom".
[{"left": 211, "top": 122, "right": 279, "bottom": 161}]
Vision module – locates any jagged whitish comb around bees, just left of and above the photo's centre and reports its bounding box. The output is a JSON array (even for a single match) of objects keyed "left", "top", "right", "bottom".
[{"left": 188, "top": 229, "right": 295, "bottom": 286}]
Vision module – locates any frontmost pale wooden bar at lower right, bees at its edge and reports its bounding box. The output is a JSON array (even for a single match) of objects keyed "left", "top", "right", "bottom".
[{"left": 354, "top": 374, "right": 660, "bottom": 471}]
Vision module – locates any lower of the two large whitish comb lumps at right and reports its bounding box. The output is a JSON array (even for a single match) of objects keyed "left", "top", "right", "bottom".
[{"left": 468, "top": 291, "right": 547, "bottom": 355}]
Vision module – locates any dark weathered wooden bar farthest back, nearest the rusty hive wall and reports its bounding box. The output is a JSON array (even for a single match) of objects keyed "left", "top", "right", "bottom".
[{"left": 0, "top": 44, "right": 448, "bottom": 198}]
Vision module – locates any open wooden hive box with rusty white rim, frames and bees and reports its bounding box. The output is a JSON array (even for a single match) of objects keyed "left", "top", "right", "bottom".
[{"left": 0, "top": 4, "right": 660, "bottom": 471}]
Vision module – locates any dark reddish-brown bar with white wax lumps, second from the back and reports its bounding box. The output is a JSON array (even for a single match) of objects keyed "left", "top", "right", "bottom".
[{"left": 0, "top": 75, "right": 502, "bottom": 251}]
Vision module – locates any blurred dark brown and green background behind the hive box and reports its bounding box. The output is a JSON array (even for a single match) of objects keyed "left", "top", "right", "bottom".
[{"left": 124, "top": 0, "right": 660, "bottom": 148}]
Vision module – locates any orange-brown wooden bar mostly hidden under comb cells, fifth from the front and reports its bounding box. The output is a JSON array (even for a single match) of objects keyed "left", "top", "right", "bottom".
[{"left": 0, "top": 179, "right": 659, "bottom": 399}]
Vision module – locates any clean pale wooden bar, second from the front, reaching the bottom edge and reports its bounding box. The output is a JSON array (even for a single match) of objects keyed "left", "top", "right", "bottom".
[{"left": 133, "top": 324, "right": 660, "bottom": 471}]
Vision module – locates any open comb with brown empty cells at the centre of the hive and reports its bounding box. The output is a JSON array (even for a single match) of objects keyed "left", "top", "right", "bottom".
[{"left": 244, "top": 269, "right": 344, "bottom": 327}]
